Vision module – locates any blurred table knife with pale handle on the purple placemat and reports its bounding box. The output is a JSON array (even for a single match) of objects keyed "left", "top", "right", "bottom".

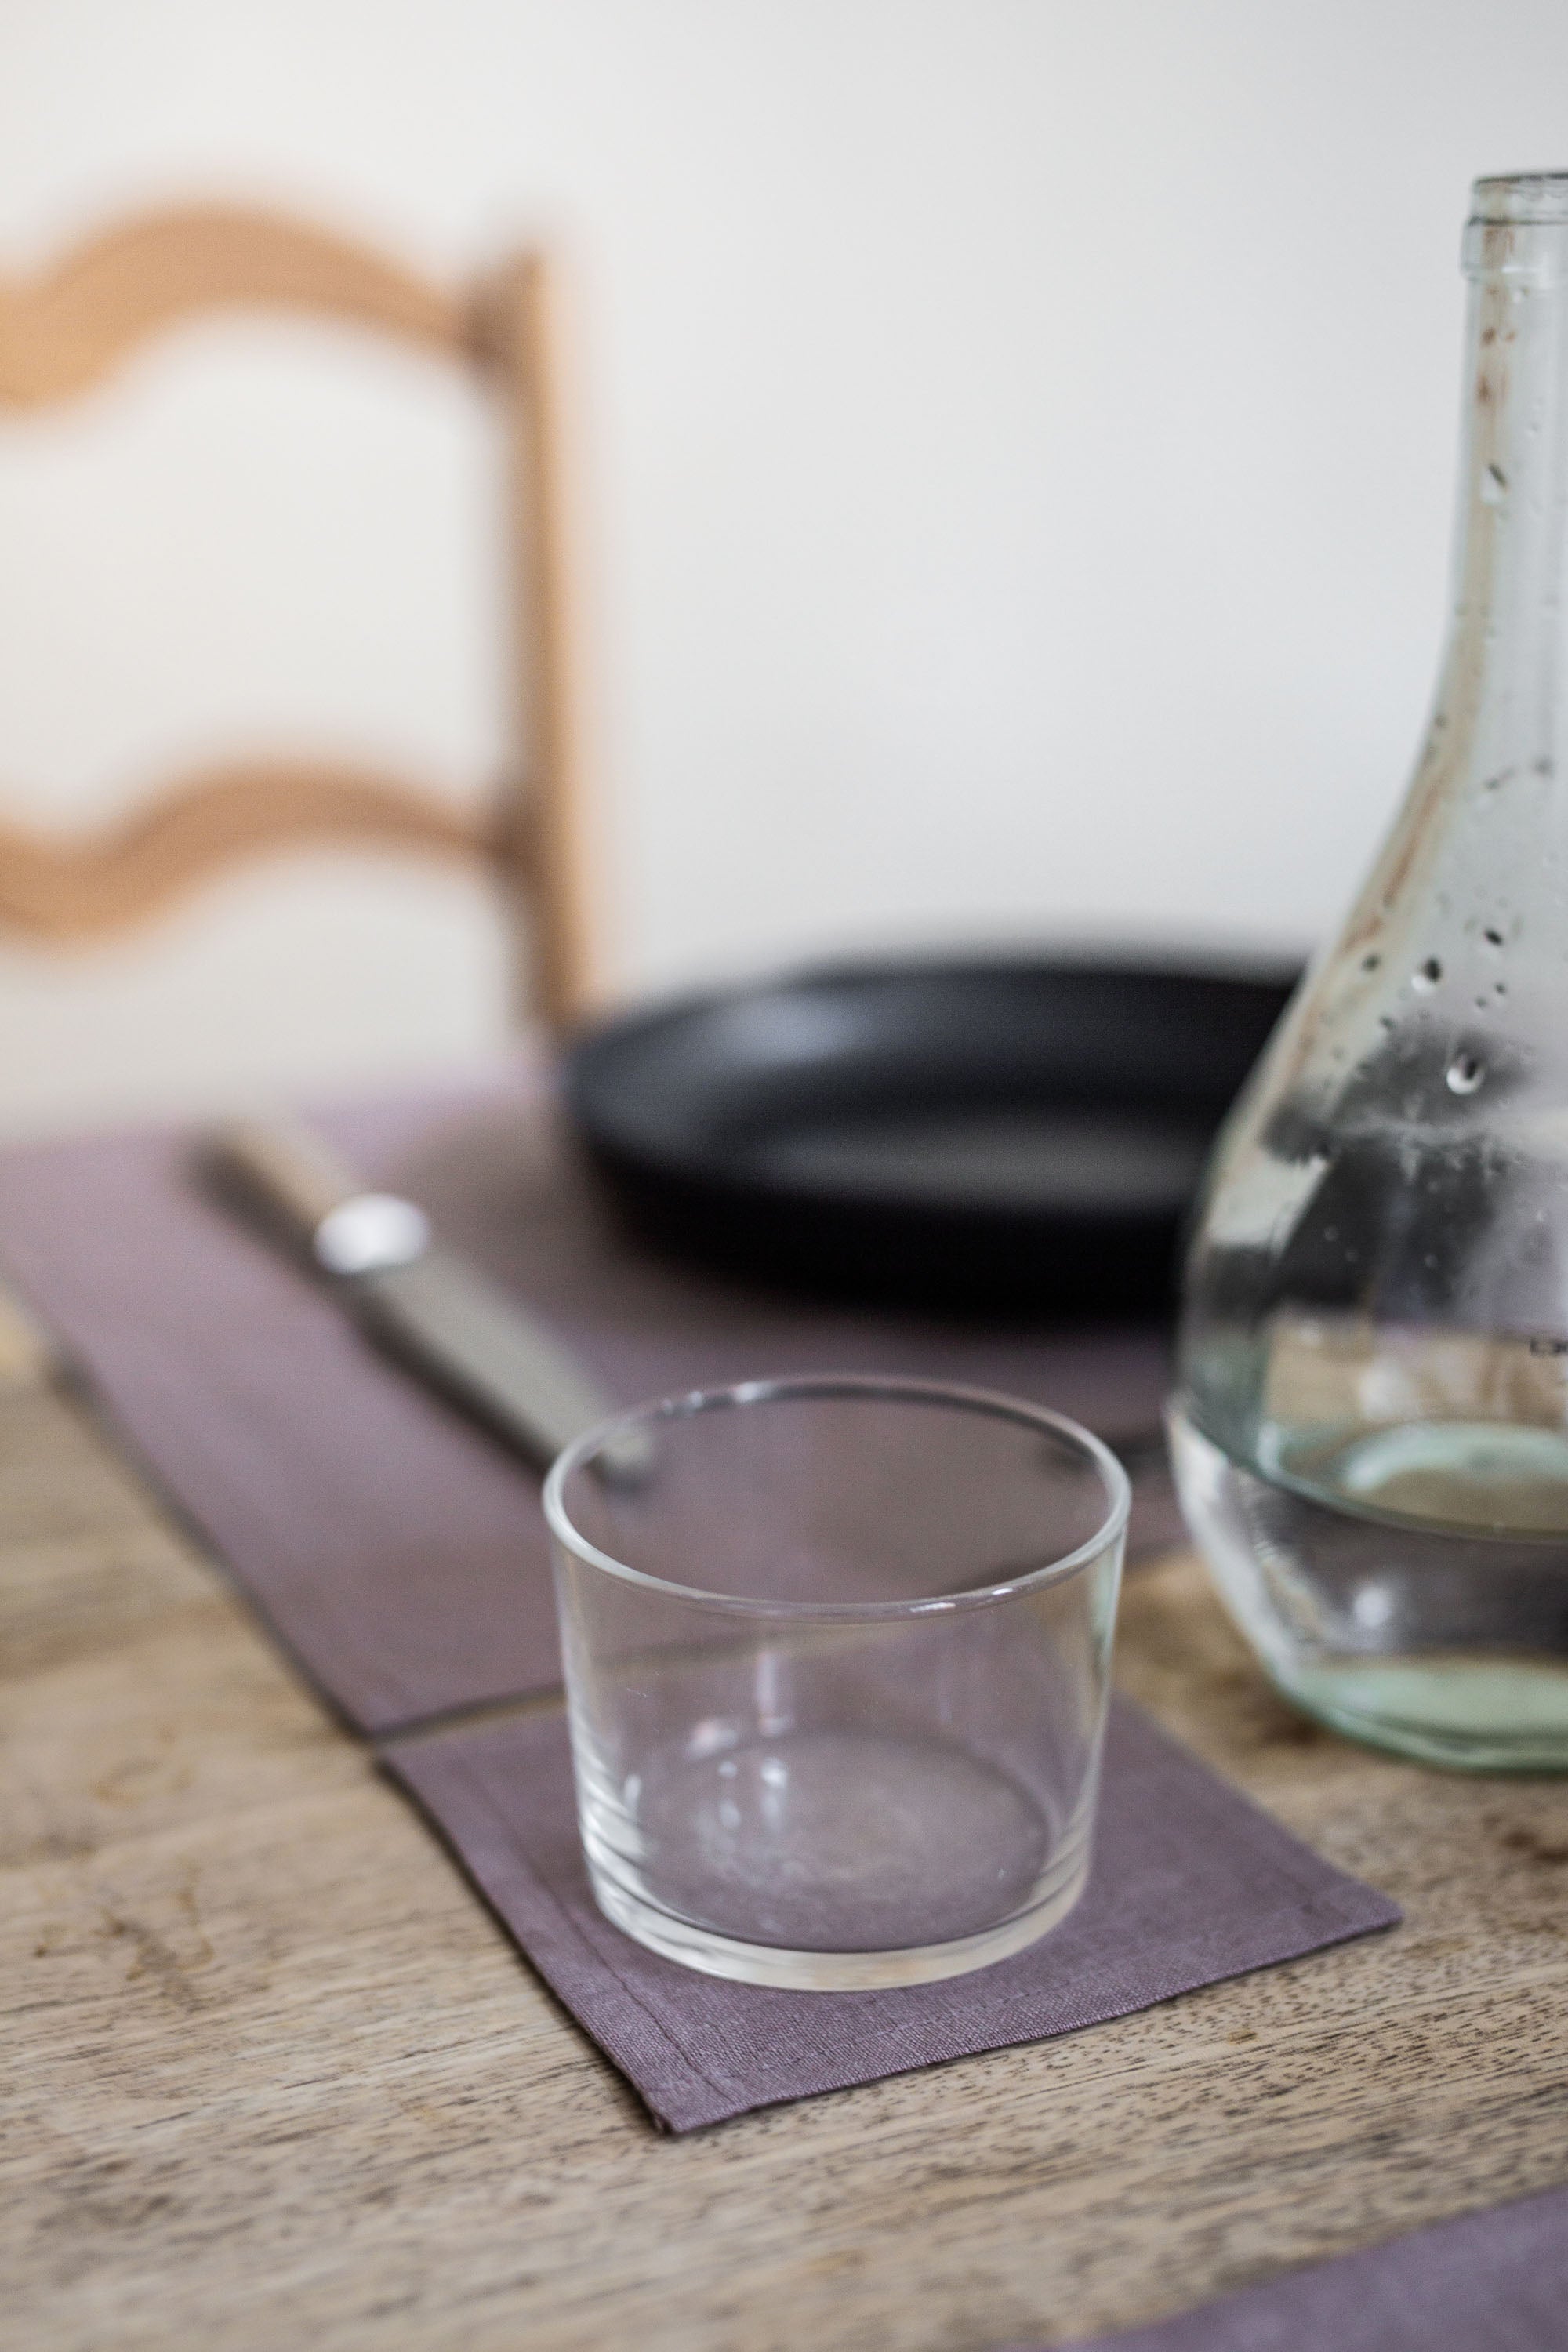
[{"left": 212, "top": 1122, "right": 614, "bottom": 1468}]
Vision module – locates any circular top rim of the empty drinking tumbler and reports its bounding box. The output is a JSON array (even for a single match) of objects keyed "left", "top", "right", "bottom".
[{"left": 543, "top": 1371, "right": 1133, "bottom": 1623}]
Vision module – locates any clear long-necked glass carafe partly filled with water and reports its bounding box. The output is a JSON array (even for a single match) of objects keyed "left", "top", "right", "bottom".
[{"left": 1173, "top": 174, "right": 1568, "bottom": 1771}]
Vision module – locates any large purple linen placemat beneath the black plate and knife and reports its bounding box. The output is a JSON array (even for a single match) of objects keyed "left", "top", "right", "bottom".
[{"left": 0, "top": 1077, "right": 1180, "bottom": 1733}]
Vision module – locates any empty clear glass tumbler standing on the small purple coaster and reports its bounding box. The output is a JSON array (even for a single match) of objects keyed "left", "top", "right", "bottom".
[{"left": 546, "top": 1378, "right": 1128, "bottom": 1990}]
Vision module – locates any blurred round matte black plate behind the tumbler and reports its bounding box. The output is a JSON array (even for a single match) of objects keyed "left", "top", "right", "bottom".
[{"left": 567, "top": 960, "right": 1298, "bottom": 1317}]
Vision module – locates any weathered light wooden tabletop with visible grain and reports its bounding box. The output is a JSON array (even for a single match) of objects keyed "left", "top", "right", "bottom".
[{"left": 0, "top": 1385, "right": 1568, "bottom": 2352}]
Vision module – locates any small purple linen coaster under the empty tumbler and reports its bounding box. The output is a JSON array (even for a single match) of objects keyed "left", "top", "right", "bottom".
[{"left": 381, "top": 1700, "right": 1399, "bottom": 2131}]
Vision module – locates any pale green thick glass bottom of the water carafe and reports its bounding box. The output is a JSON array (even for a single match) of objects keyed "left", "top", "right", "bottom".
[{"left": 1272, "top": 1658, "right": 1568, "bottom": 1773}]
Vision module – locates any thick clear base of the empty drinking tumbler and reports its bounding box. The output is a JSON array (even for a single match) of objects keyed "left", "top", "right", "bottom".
[{"left": 588, "top": 1839, "right": 1088, "bottom": 1992}]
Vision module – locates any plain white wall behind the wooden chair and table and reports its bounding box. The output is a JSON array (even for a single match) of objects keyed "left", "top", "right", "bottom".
[{"left": 0, "top": 0, "right": 1568, "bottom": 1127}]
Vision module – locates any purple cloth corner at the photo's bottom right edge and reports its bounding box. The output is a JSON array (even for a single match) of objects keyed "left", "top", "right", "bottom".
[{"left": 1013, "top": 2190, "right": 1568, "bottom": 2352}]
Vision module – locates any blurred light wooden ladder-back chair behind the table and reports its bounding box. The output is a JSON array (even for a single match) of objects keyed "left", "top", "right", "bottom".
[{"left": 0, "top": 207, "right": 597, "bottom": 1028}]
